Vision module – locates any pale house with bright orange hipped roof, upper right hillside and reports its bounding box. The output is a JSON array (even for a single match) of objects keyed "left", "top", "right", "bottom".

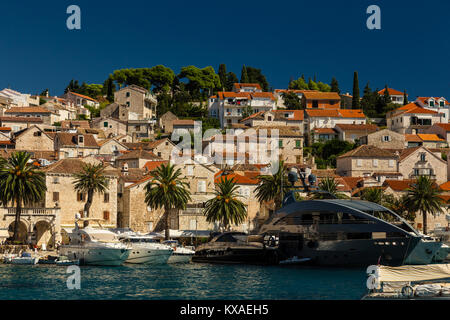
[{"left": 386, "top": 102, "right": 447, "bottom": 134}]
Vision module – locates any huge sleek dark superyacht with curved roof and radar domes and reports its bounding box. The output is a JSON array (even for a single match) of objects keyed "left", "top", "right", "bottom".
[{"left": 260, "top": 190, "right": 442, "bottom": 266}]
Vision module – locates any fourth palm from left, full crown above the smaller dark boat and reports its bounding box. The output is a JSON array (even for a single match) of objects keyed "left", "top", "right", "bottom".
[{"left": 204, "top": 176, "right": 247, "bottom": 230}]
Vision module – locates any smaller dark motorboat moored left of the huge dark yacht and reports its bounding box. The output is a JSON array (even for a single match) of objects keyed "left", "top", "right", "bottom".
[{"left": 192, "top": 232, "right": 279, "bottom": 265}]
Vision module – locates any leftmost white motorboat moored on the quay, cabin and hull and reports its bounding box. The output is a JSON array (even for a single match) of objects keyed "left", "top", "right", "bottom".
[{"left": 59, "top": 219, "right": 131, "bottom": 266}]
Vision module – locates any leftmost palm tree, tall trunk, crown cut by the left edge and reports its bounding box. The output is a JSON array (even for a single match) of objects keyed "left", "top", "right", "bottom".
[{"left": 0, "top": 151, "right": 47, "bottom": 241}]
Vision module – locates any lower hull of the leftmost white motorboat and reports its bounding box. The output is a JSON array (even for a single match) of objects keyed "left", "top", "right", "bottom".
[{"left": 60, "top": 246, "right": 130, "bottom": 266}]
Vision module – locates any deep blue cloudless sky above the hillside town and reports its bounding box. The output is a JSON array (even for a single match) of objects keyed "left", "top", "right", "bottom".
[{"left": 0, "top": 0, "right": 450, "bottom": 99}]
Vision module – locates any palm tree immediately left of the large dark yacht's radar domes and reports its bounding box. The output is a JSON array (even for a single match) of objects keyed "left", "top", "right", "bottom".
[{"left": 255, "top": 161, "right": 289, "bottom": 212}]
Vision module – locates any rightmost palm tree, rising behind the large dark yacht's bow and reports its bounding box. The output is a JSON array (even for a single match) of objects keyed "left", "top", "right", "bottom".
[{"left": 405, "top": 176, "right": 443, "bottom": 234}]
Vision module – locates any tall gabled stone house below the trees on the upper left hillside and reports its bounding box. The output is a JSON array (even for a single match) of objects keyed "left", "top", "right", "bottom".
[{"left": 114, "top": 85, "right": 157, "bottom": 120}]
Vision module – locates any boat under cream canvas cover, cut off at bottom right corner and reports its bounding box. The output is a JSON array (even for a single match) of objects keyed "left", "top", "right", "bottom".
[{"left": 362, "top": 264, "right": 450, "bottom": 300}]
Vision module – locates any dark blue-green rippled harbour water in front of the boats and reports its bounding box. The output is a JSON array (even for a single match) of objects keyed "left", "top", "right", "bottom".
[{"left": 0, "top": 263, "right": 367, "bottom": 300}]
